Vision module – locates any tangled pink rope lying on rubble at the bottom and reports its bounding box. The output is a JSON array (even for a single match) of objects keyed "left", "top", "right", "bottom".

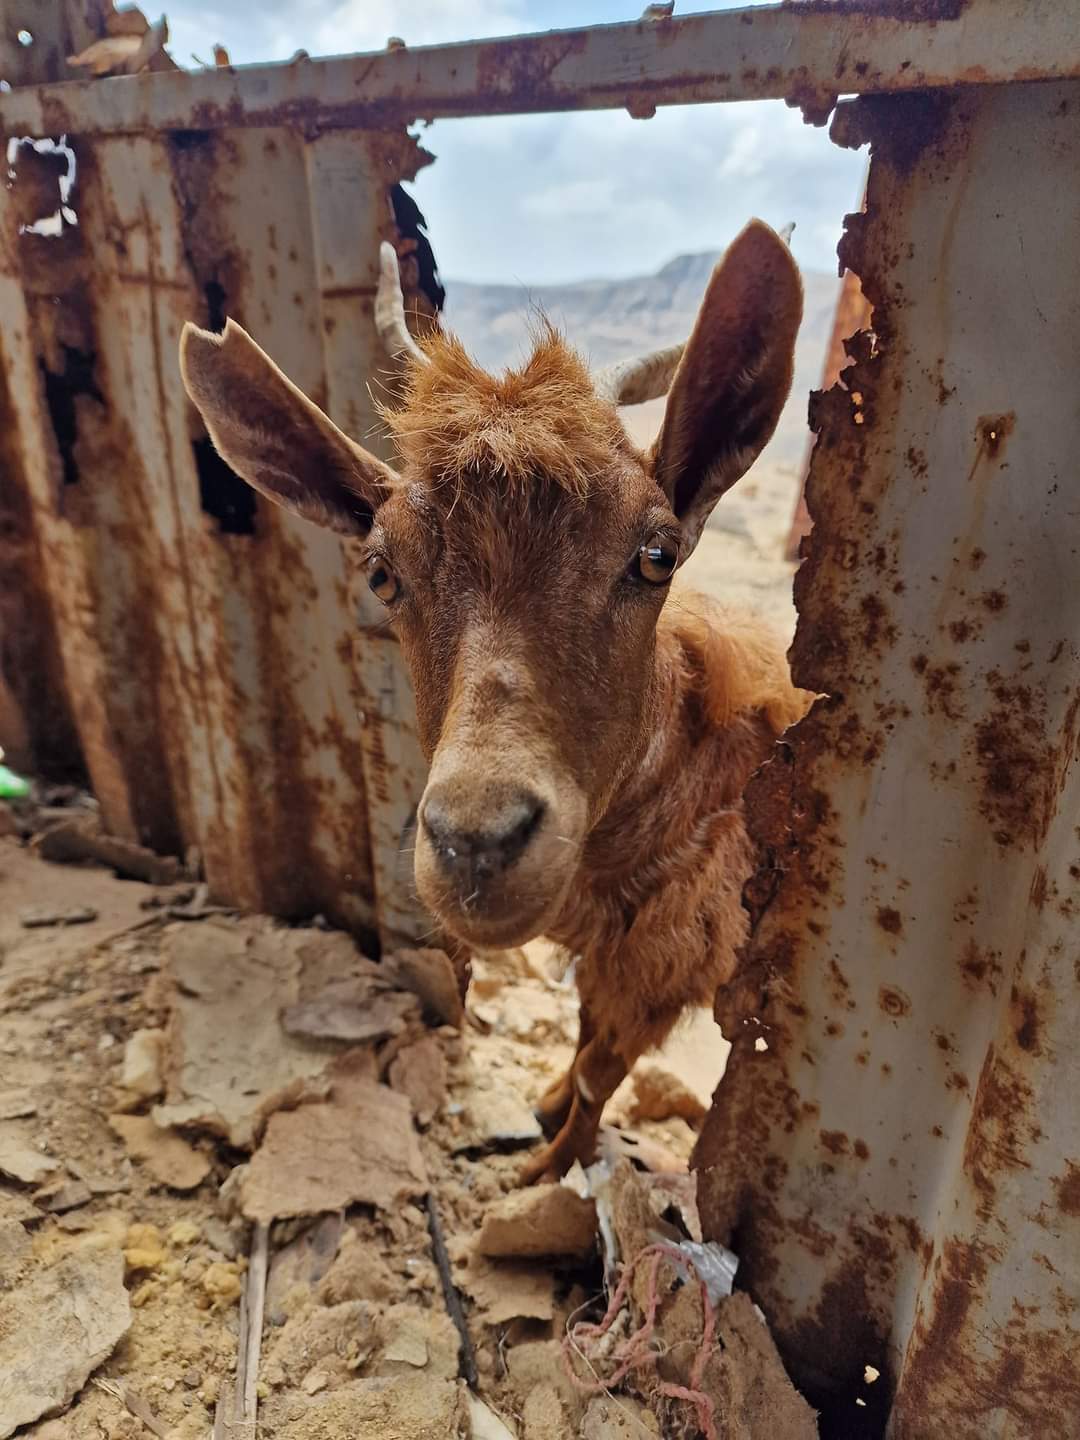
[{"left": 563, "top": 1243, "right": 719, "bottom": 1440}]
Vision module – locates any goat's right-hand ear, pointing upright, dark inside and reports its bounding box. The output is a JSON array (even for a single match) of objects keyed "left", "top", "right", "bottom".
[{"left": 651, "top": 220, "right": 802, "bottom": 549}]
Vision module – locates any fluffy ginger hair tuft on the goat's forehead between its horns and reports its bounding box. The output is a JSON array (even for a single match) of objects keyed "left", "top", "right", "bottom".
[{"left": 383, "top": 325, "right": 636, "bottom": 500}]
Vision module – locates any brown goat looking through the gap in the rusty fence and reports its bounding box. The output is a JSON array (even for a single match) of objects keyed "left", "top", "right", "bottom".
[{"left": 181, "top": 222, "right": 808, "bottom": 1179}]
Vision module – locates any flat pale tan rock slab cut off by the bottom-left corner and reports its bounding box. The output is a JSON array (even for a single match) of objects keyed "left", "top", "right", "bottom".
[{"left": 0, "top": 1248, "right": 131, "bottom": 1440}]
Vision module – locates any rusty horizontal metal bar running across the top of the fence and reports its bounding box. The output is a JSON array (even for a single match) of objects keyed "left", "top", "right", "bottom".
[{"left": 0, "top": 0, "right": 1080, "bottom": 135}]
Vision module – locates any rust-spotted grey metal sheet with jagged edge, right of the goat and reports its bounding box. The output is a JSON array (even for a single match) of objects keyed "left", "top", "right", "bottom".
[{"left": 698, "top": 84, "right": 1080, "bottom": 1440}]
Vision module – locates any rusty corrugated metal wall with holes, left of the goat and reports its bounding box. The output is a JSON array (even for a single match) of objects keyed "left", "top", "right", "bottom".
[{"left": 0, "top": 130, "right": 426, "bottom": 937}]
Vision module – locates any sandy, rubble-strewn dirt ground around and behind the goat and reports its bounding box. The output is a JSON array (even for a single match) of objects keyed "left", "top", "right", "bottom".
[{"left": 0, "top": 472, "right": 816, "bottom": 1440}]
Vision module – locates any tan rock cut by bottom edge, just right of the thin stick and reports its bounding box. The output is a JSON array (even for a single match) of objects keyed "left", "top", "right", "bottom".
[{"left": 269, "top": 1372, "right": 469, "bottom": 1440}]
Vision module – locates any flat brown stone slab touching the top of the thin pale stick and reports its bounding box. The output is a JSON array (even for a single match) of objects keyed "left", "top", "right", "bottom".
[{"left": 239, "top": 1079, "right": 428, "bottom": 1223}]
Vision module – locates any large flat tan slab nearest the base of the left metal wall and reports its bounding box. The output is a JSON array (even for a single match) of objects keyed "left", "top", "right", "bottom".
[{"left": 153, "top": 919, "right": 338, "bottom": 1149}]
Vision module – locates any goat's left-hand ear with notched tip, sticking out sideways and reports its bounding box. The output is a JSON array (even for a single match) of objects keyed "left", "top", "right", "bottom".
[{"left": 180, "top": 320, "right": 396, "bottom": 536}]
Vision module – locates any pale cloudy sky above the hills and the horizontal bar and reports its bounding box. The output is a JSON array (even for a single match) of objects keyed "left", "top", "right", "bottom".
[{"left": 168, "top": 0, "right": 865, "bottom": 285}]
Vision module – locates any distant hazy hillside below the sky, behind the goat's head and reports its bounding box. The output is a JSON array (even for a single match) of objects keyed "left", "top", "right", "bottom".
[{"left": 445, "top": 252, "right": 840, "bottom": 468}]
